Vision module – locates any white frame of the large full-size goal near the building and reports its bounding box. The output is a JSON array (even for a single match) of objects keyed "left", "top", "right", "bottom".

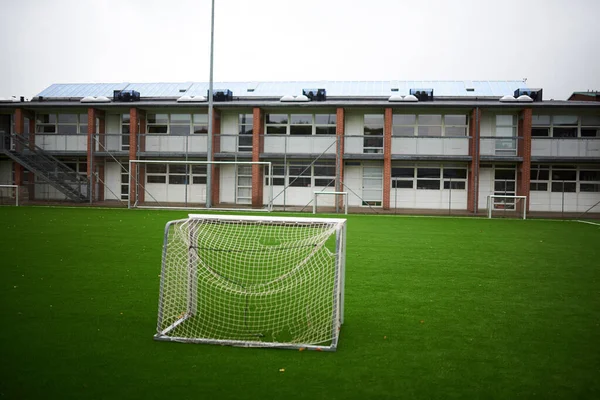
[{"left": 127, "top": 160, "right": 273, "bottom": 212}]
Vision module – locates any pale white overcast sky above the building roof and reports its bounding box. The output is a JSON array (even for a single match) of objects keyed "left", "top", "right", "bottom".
[{"left": 0, "top": 0, "right": 600, "bottom": 99}]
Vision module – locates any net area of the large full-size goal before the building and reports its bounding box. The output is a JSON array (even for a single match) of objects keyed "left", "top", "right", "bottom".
[{"left": 131, "top": 160, "right": 273, "bottom": 211}]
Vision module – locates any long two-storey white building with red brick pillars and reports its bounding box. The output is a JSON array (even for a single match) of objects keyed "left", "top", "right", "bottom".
[{"left": 0, "top": 81, "right": 600, "bottom": 213}]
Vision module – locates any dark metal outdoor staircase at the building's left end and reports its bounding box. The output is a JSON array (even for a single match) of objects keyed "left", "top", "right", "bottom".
[{"left": 0, "top": 134, "right": 89, "bottom": 203}]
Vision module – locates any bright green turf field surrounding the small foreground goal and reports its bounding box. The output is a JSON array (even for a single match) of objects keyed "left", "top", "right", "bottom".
[{"left": 0, "top": 207, "right": 600, "bottom": 400}]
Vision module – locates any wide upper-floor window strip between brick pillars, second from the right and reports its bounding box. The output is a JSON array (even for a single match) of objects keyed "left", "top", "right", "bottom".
[{"left": 392, "top": 114, "right": 468, "bottom": 137}]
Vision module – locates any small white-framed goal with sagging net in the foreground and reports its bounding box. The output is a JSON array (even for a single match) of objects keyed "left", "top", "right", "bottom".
[{"left": 154, "top": 215, "right": 346, "bottom": 350}]
